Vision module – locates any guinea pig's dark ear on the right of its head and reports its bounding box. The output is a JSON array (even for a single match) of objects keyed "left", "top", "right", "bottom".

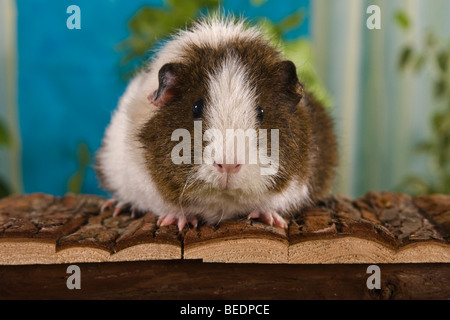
[{"left": 279, "top": 60, "right": 303, "bottom": 112}]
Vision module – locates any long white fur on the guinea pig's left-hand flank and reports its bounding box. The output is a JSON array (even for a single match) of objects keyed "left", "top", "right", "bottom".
[{"left": 99, "top": 74, "right": 177, "bottom": 215}]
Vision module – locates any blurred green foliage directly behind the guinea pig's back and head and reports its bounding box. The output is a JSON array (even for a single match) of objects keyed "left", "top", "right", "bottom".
[{"left": 118, "top": 0, "right": 331, "bottom": 105}]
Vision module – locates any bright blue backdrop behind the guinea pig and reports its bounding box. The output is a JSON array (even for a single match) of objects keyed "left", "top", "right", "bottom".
[{"left": 17, "top": 0, "right": 309, "bottom": 195}]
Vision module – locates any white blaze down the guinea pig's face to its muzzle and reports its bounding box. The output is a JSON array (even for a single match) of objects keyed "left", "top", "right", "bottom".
[{"left": 196, "top": 56, "right": 273, "bottom": 196}]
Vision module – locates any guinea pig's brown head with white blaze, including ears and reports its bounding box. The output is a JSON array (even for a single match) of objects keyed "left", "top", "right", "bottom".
[{"left": 139, "top": 39, "right": 310, "bottom": 208}]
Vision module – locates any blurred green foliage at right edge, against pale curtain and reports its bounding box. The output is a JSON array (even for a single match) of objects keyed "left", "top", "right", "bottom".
[{"left": 396, "top": 12, "right": 450, "bottom": 195}]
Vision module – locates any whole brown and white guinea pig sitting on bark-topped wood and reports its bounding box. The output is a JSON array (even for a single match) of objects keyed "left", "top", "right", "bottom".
[{"left": 97, "top": 16, "right": 337, "bottom": 230}]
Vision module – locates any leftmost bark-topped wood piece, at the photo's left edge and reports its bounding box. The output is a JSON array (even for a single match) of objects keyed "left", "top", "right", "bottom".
[{"left": 0, "top": 193, "right": 103, "bottom": 264}]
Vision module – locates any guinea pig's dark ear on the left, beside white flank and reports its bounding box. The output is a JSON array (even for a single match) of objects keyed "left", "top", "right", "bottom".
[{"left": 148, "top": 63, "right": 183, "bottom": 107}]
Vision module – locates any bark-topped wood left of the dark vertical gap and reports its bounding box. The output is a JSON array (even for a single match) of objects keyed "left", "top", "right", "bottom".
[{"left": 0, "top": 193, "right": 181, "bottom": 264}]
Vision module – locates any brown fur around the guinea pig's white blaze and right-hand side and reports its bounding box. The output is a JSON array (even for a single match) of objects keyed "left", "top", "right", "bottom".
[{"left": 137, "top": 31, "right": 337, "bottom": 209}]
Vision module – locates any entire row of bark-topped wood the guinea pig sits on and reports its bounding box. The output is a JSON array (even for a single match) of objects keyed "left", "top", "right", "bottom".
[{"left": 0, "top": 192, "right": 450, "bottom": 265}]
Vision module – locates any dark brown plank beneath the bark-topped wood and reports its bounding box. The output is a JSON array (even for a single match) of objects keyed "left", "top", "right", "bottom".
[{"left": 0, "top": 260, "right": 450, "bottom": 300}]
